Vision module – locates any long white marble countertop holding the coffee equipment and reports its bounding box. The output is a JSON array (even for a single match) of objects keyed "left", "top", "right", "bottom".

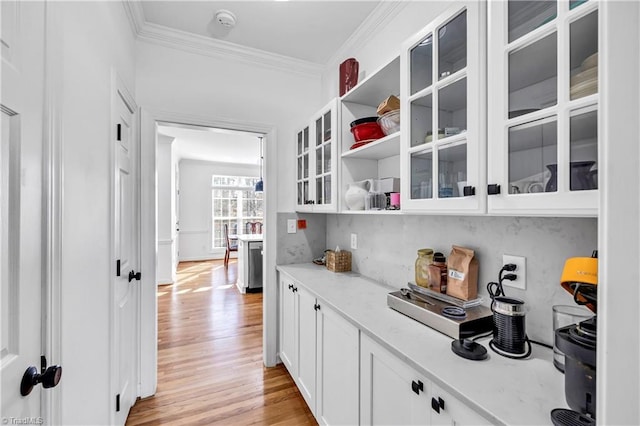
[{"left": 277, "top": 263, "right": 567, "bottom": 425}]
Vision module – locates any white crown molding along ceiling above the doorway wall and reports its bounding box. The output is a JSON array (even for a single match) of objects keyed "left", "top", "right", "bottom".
[{"left": 138, "top": 22, "right": 324, "bottom": 77}]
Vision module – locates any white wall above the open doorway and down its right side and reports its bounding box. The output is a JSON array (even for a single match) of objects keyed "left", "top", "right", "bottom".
[{"left": 137, "top": 41, "right": 323, "bottom": 211}]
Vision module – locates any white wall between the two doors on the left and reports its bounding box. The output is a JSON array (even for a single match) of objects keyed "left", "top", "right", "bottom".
[{"left": 53, "top": 2, "right": 135, "bottom": 425}]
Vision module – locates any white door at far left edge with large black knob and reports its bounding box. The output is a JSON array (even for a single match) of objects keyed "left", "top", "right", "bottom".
[{"left": 0, "top": 1, "right": 44, "bottom": 424}]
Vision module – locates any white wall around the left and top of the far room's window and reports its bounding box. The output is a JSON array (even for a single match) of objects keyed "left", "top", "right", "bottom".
[{"left": 179, "top": 160, "right": 260, "bottom": 261}]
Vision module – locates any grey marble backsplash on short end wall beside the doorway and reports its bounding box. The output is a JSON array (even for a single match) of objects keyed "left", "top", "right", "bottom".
[{"left": 276, "top": 213, "right": 327, "bottom": 265}]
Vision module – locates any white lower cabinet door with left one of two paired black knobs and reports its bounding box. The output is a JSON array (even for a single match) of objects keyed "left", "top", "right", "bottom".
[{"left": 360, "top": 334, "right": 430, "bottom": 425}]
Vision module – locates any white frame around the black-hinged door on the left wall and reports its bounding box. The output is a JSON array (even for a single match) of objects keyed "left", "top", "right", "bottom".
[{"left": 109, "top": 68, "right": 139, "bottom": 424}]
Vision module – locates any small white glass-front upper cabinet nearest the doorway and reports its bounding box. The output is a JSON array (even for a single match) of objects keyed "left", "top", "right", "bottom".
[{"left": 296, "top": 99, "right": 338, "bottom": 212}]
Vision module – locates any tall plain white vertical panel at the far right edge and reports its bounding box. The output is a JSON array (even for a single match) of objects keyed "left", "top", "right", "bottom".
[{"left": 596, "top": 1, "right": 640, "bottom": 425}]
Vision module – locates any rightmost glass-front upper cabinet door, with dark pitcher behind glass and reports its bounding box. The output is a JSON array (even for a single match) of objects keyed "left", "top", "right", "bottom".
[{"left": 488, "top": 0, "right": 599, "bottom": 216}]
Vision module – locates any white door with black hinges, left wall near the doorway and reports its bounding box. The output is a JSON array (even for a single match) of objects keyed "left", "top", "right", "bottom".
[{"left": 113, "top": 90, "right": 140, "bottom": 425}]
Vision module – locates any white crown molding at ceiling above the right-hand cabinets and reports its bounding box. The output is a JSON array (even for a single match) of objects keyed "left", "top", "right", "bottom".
[{"left": 325, "top": 0, "right": 409, "bottom": 70}]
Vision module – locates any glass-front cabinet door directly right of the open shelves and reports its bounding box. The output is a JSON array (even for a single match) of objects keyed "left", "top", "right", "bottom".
[{"left": 400, "top": 2, "right": 486, "bottom": 213}]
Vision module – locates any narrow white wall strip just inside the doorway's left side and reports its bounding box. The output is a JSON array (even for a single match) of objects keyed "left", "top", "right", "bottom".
[{"left": 156, "top": 135, "right": 176, "bottom": 284}]
